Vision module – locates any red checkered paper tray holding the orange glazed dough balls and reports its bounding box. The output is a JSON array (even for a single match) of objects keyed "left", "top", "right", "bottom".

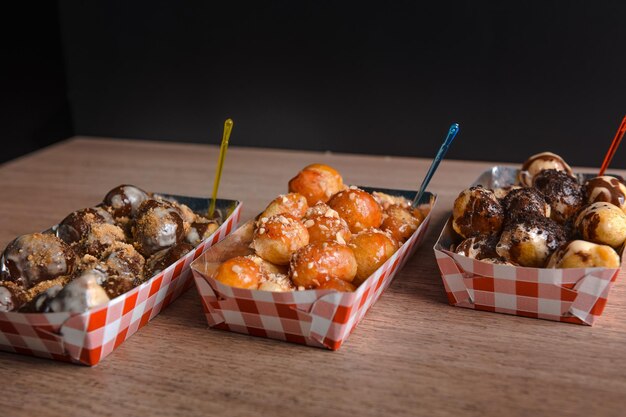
[{"left": 191, "top": 187, "right": 435, "bottom": 350}]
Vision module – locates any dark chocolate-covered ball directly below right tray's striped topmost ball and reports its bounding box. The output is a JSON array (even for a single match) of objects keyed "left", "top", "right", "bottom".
[{"left": 533, "top": 169, "right": 584, "bottom": 224}]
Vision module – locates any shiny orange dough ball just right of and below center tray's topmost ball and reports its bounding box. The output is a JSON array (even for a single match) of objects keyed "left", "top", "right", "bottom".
[{"left": 328, "top": 188, "right": 383, "bottom": 233}]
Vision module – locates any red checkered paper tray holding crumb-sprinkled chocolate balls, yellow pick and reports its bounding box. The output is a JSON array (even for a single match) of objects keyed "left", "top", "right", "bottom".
[{"left": 0, "top": 194, "right": 241, "bottom": 366}]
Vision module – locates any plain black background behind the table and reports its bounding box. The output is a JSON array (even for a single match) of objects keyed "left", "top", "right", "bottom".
[{"left": 0, "top": 1, "right": 626, "bottom": 168}]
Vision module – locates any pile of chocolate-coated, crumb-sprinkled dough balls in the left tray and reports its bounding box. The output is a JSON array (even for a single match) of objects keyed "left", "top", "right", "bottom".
[{"left": 0, "top": 185, "right": 219, "bottom": 313}]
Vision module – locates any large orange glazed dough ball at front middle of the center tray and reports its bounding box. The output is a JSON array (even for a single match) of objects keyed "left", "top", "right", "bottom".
[{"left": 290, "top": 242, "right": 357, "bottom": 289}]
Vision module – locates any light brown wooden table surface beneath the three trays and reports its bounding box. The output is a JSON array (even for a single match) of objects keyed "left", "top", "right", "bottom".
[{"left": 0, "top": 137, "right": 626, "bottom": 417}]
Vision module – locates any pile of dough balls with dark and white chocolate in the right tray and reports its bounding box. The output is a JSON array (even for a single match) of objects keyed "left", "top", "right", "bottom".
[{"left": 451, "top": 152, "right": 626, "bottom": 268}]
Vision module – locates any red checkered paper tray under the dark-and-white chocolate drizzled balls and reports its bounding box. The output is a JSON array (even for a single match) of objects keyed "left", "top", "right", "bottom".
[{"left": 434, "top": 166, "right": 624, "bottom": 325}]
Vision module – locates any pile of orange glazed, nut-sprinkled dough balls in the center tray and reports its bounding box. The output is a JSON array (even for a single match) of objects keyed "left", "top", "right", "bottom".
[{"left": 213, "top": 164, "right": 426, "bottom": 292}]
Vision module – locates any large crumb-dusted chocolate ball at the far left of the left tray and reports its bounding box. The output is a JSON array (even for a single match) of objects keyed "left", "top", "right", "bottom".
[{"left": 2, "top": 233, "right": 77, "bottom": 288}]
